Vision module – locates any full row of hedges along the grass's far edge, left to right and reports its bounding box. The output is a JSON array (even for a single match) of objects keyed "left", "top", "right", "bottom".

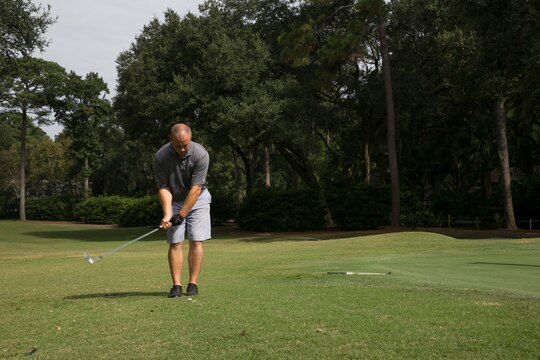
[{"left": 21, "top": 177, "right": 540, "bottom": 231}]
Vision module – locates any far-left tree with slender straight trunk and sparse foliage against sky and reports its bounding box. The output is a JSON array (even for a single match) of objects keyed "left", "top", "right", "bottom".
[{"left": 0, "top": 0, "right": 57, "bottom": 220}]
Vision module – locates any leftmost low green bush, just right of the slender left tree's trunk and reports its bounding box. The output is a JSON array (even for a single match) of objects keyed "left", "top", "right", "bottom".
[{"left": 26, "top": 195, "right": 77, "bottom": 221}]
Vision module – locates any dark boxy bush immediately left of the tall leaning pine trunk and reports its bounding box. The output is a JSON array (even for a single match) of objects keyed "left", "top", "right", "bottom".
[{"left": 327, "top": 184, "right": 392, "bottom": 230}]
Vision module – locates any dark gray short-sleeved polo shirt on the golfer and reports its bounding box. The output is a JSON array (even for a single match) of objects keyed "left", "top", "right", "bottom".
[{"left": 154, "top": 141, "right": 210, "bottom": 201}]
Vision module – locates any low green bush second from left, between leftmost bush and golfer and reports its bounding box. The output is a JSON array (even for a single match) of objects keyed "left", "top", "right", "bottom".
[{"left": 75, "top": 196, "right": 137, "bottom": 224}]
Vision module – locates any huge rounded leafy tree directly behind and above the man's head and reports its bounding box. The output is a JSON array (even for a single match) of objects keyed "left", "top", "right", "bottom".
[{"left": 115, "top": 5, "right": 280, "bottom": 197}]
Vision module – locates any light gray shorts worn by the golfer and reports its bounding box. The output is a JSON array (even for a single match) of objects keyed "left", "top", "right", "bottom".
[{"left": 167, "top": 189, "right": 212, "bottom": 244}]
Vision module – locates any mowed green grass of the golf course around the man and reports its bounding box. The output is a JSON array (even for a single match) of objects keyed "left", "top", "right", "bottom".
[{"left": 0, "top": 221, "right": 540, "bottom": 359}]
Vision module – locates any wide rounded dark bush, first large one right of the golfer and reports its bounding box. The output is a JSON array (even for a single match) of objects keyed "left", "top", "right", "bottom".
[{"left": 238, "top": 190, "right": 324, "bottom": 231}]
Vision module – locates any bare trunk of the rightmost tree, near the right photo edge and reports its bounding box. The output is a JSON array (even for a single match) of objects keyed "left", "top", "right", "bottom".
[{"left": 495, "top": 98, "right": 517, "bottom": 230}]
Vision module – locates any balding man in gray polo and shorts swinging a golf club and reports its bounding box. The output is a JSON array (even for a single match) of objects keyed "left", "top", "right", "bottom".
[{"left": 154, "top": 124, "right": 212, "bottom": 298}]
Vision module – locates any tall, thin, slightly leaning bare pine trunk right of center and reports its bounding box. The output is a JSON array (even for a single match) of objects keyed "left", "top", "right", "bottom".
[{"left": 378, "top": 16, "right": 401, "bottom": 227}]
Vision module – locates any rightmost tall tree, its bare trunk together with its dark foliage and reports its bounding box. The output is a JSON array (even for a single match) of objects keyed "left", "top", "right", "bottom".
[{"left": 448, "top": 1, "right": 533, "bottom": 229}]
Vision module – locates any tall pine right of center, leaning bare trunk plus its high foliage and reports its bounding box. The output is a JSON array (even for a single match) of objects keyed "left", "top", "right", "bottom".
[{"left": 283, "top": 0, "right": 400, "bottom": 227}]
